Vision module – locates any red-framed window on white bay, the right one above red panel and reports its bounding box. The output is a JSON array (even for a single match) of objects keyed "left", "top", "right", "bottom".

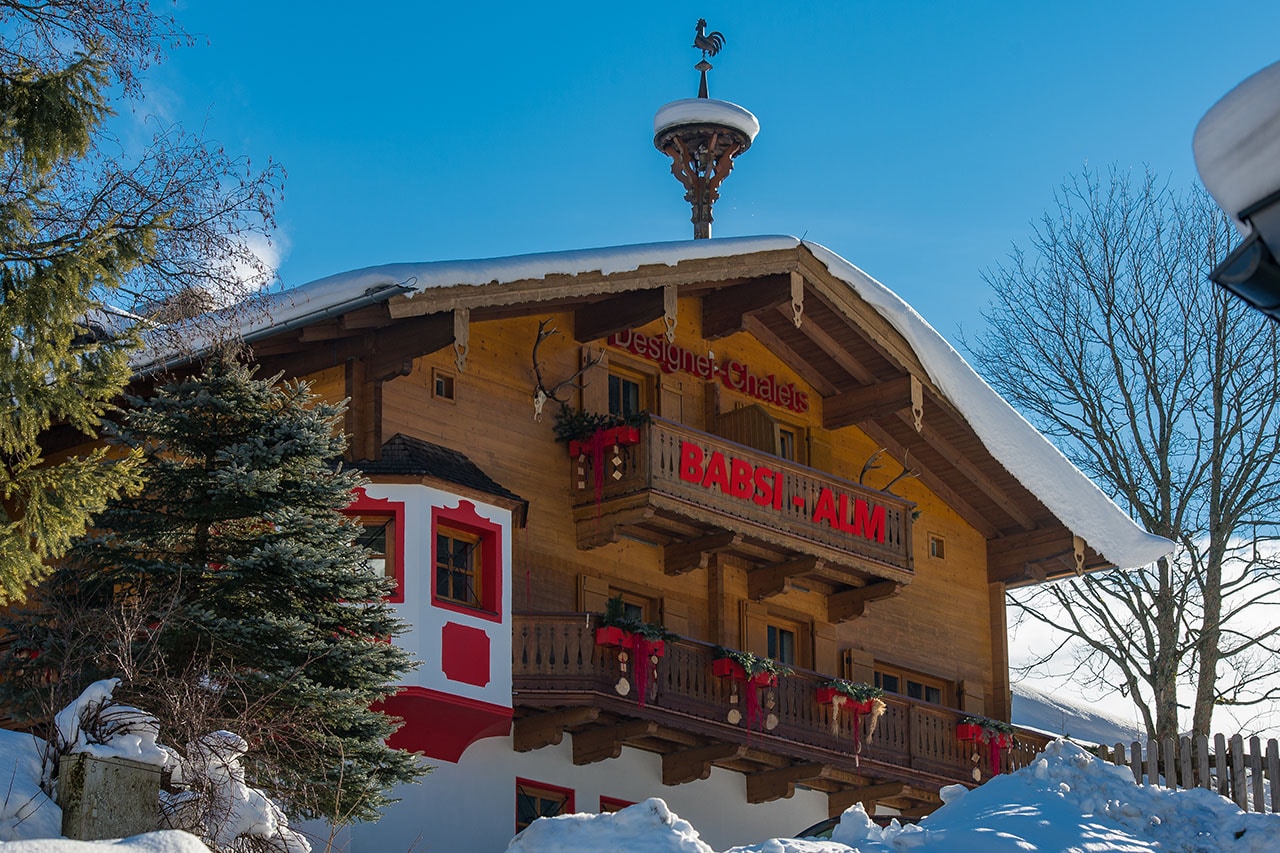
[{"left": 430, "top": 500, "right": 503, "bottom": 621}]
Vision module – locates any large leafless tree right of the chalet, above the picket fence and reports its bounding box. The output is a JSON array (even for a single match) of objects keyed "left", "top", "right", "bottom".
[{"left": 970, "top": 170, "right": 1280, "bottom": 738}]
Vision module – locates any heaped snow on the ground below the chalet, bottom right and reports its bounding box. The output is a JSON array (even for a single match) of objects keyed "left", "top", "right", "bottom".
[{"left": 507, "top": 740, "right": 1280, "bottom": 853}]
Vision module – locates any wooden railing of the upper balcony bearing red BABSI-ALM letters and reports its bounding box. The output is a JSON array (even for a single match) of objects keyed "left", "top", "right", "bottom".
[{"left": 573, "top": 418, "right": 914, "bottom": 574}]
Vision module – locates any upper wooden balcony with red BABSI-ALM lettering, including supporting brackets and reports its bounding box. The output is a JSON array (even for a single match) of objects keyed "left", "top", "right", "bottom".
[{"left": 571, "top": 418, "right": 914, "bottom": 589}]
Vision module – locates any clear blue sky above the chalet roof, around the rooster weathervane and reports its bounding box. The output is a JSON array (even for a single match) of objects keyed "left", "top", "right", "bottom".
[{"left": 145, "top": 0, "right": 1280, "bottom": 338}]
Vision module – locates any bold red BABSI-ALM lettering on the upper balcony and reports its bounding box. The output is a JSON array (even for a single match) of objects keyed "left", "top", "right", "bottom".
[{"left": 680, "top": 442, "right": 884, "bottom": 543}]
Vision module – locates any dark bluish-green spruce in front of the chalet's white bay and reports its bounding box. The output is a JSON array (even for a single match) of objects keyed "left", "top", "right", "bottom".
[{"left": 0, "top": 357, "right": 422, "bottom": 824}]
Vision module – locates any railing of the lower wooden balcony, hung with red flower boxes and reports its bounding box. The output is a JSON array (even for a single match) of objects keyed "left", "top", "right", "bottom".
[{"left": 512, "top": 613, "right": 1048, "bottom": 783}]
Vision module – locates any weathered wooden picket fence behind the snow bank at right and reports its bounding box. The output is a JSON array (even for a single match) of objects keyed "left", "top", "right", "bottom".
[{"left": 1101, "top": 734, "right": 1280, "bottom": 813}]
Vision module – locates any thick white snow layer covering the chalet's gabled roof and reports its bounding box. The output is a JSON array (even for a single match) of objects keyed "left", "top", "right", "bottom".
[{"left": 134, "top": 236, "right": 1172, "bottom": 567}]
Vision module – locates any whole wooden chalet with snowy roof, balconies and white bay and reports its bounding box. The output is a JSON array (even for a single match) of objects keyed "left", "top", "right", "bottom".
[{"left": 140, "top": 230, "right": 1167, "bottom": 849}]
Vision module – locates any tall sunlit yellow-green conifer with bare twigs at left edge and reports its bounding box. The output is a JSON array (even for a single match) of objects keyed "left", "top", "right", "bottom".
[{"left": 0, "top": 0, "right": 279, "bottom": 596}]
